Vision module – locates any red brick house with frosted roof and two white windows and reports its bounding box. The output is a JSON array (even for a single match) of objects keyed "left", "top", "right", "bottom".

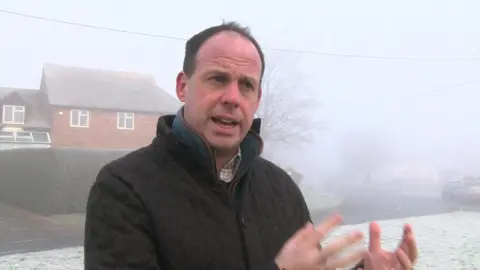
[{"left": 0, "top": 64, "right": 181, "bottom": 149}]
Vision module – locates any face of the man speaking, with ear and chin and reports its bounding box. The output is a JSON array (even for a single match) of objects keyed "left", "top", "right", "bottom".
[{"left": 177, "top": 32, "right": 262, "bottom": 151}]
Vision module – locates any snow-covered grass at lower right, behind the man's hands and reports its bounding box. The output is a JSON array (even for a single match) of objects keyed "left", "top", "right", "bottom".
[{"left": 327, "top": 212, "right": 480, "bottom": 270}]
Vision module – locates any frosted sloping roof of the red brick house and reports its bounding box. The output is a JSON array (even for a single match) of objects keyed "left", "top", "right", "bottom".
[{"left": 42, "top": 64, "right": 181, "bottom": 113}]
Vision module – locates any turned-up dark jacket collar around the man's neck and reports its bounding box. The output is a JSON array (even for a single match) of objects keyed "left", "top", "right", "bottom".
[{"left": 157, "top": 107, "right": 263, "bottom": 178}]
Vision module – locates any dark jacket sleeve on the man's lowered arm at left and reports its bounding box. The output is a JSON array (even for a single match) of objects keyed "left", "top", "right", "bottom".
[{"left": 84, "top": 167, "right": 160, "bottom": 270}]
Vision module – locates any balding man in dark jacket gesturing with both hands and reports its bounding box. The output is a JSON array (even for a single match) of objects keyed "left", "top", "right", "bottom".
[{"left": 85, "top": 23, "right": 416, "bottom": 270}]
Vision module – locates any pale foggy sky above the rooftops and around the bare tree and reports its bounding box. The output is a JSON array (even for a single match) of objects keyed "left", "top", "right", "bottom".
[{"left": 0, "top": 0, "right": 480, "bottom": 181}]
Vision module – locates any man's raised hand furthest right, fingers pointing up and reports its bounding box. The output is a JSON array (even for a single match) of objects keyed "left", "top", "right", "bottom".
[{"left": 364, "top": 222, "right": 418, "bottom": 270}]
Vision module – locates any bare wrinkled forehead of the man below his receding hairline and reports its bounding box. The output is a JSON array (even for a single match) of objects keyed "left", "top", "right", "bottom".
[{"left": 196, "top": 32, "right": 262, "bottom": 77}]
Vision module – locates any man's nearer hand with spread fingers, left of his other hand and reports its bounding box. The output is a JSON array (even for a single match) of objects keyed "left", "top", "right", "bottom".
[{"left": 275, "top": 216, "right": 365, "bottom": 270}]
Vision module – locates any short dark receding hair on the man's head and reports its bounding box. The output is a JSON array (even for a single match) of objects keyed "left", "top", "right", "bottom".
[{"left": 183, "top": 21, "right": 265, "bottom": 79}]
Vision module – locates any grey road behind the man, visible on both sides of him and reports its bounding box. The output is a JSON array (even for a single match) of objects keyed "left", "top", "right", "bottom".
[{"left": 0, "top": 192, "right": 480, "bottom": 256}]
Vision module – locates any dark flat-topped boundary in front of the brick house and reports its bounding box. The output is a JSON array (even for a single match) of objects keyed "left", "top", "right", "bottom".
[{"left": 0, "top": 148, "right": 130, "bottom": 215}]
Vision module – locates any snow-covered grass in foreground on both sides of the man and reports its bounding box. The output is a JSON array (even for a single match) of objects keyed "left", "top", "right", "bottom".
[{"left": 0, "top": 212, "right": 480, "bottom": 270}]
